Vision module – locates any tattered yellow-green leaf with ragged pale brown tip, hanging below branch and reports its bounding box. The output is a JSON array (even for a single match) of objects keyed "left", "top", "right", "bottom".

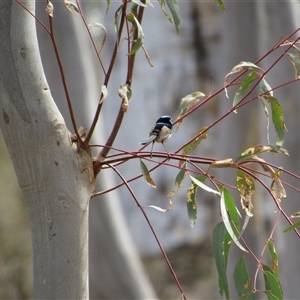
[{"left": 236, "top": 170, "right": 255, "bottom": 217}]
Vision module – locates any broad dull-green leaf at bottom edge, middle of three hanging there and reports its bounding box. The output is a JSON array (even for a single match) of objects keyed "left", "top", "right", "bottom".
[{"left": 234, "top": 257, "right": 255, "bottom": 300}]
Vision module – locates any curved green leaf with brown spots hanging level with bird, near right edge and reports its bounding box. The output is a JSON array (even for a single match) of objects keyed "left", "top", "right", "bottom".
[{"left": 263, "top": 95, "right": 286, "bottom": 147}]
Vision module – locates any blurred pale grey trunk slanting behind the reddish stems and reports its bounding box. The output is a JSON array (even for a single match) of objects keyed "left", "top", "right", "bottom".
[{"left": 36, "top": 2, "right": 156, "bottom": 299}]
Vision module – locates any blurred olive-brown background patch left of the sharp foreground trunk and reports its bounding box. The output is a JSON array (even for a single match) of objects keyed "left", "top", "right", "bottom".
[{"left": 0, "top": 132, "right": 32, "bottom": 299}]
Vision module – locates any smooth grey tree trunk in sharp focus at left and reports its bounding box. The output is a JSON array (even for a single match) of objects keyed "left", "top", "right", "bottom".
[{"left": 0, "top": 1, "right": 95, "bottom": 299}]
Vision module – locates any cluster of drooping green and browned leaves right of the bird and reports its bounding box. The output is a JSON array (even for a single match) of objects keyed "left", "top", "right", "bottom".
[{"left": 141, "top": 38, "right": 300, "bottom": 299}]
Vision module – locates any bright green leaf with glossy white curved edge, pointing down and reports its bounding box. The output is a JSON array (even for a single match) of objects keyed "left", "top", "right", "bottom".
[{"left": 218, "top": 185, "right": 248, "bottom": 252}]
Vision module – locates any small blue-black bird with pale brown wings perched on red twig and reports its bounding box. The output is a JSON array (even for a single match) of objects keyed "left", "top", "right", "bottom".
[{"left": 141, "top": 116, "right": 173, "bottom": 158}]
